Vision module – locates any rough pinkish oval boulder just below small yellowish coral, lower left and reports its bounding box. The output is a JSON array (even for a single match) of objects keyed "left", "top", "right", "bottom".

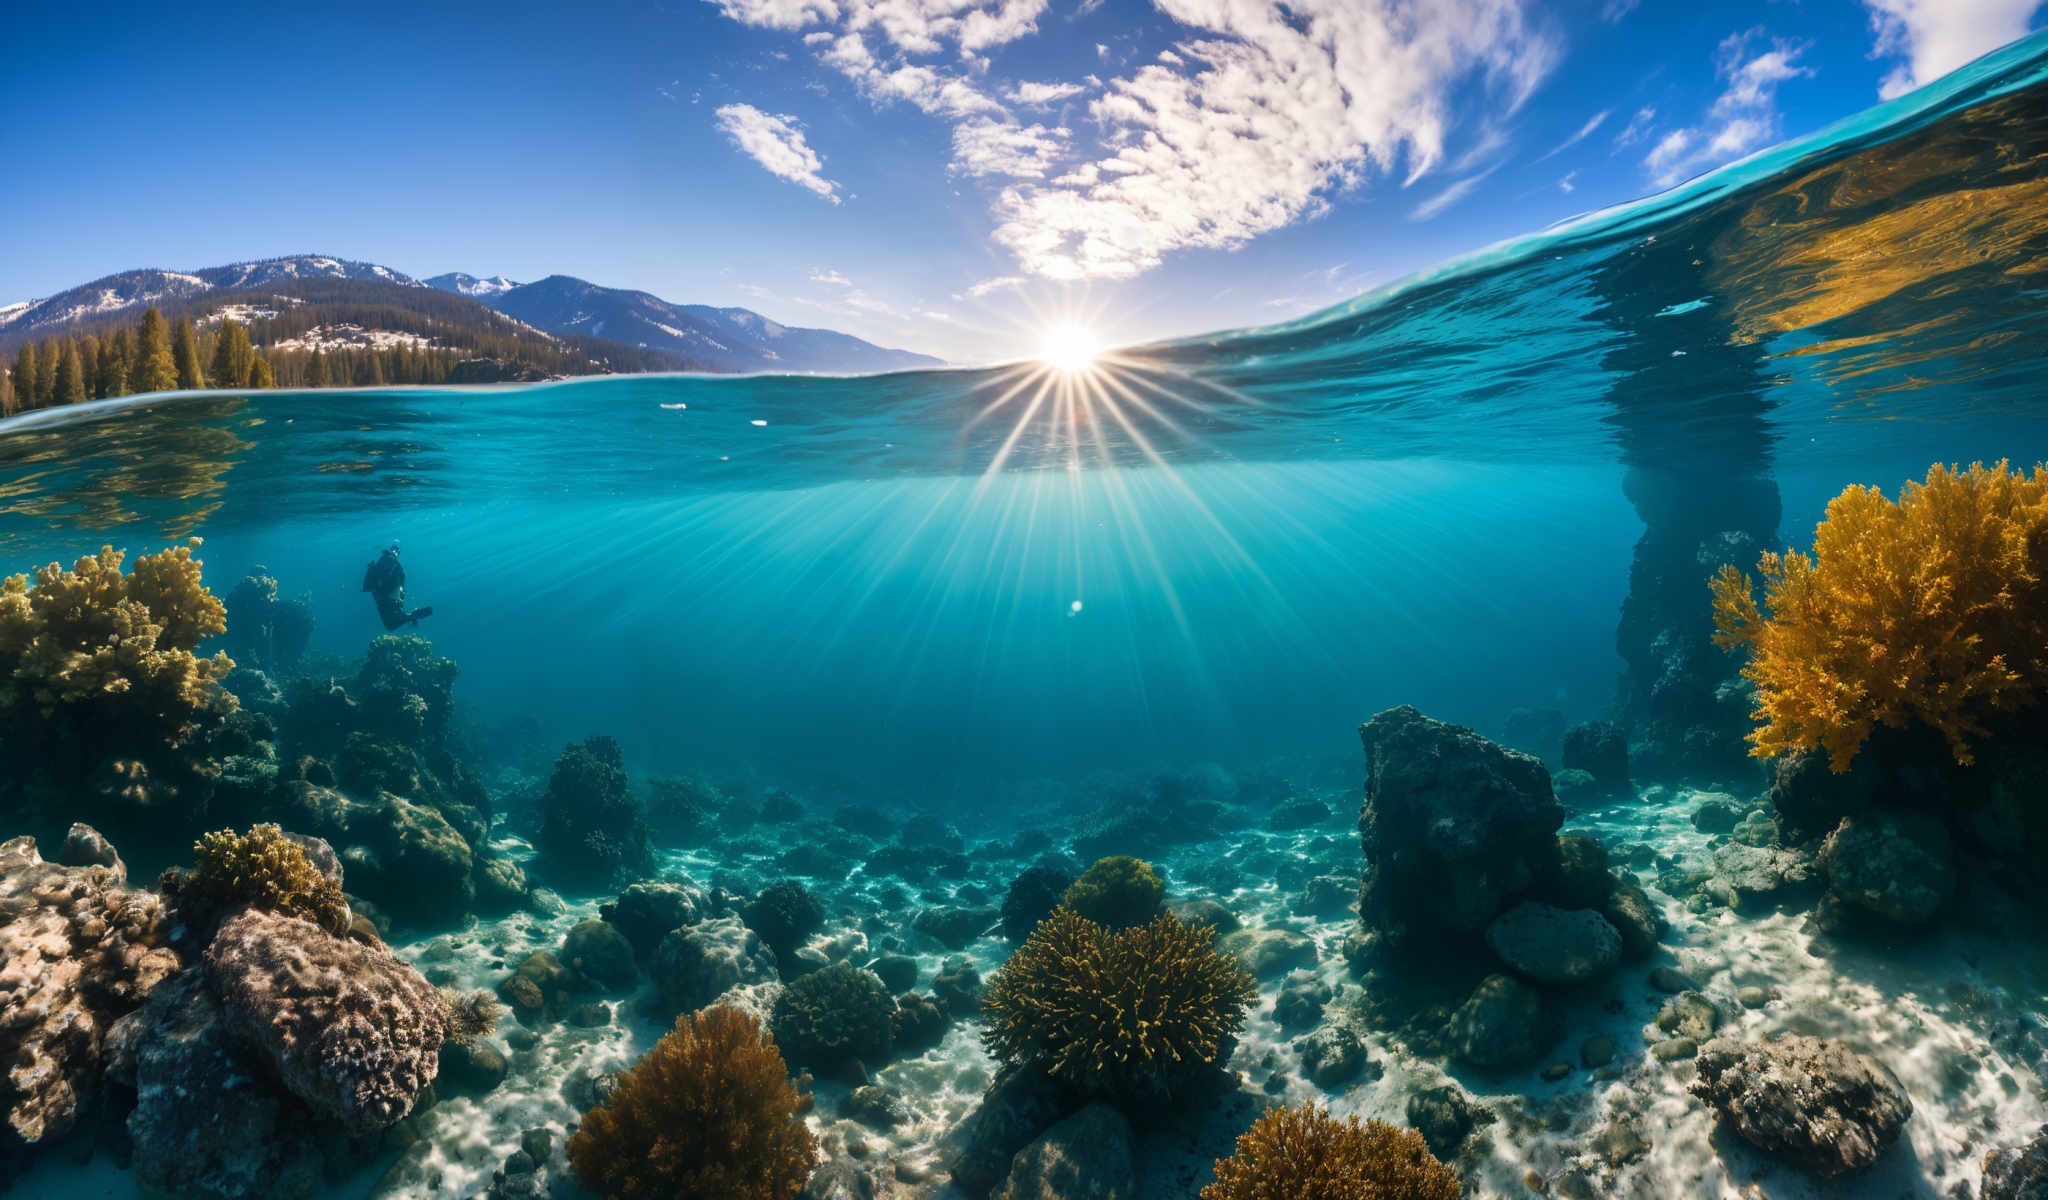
[{"left": 205, "top": 909, "right": 446, "bottom": 1134}]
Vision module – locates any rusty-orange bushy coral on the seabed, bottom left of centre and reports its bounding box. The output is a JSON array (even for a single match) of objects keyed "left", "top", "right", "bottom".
[{"left": 569, "top": 1005, "right": 815, "bottom": 1200}]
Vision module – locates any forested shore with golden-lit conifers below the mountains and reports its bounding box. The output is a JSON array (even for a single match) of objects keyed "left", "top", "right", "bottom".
[{"left": 0, "top": 286, "right": 674, "bottom": 416}]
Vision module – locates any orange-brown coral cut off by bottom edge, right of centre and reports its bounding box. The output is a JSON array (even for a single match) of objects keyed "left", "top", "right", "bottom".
[{"left": 1202, "top": 1102, "right": 1464, "bottom": 1200}]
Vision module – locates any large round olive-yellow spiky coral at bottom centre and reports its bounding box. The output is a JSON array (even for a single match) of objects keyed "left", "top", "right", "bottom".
[{"left": 981, "top": 907, "right": 1257, "bottom": 1100}]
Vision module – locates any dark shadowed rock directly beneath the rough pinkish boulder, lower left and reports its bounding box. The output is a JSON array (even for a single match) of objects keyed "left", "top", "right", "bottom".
[{"left": 121, "top": 967, "right": 322, "bottom": 1200}]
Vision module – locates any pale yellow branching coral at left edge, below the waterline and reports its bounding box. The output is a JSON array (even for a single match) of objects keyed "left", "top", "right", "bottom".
[{"left": 0, "top": 539, "right": 233, "bottom": 743}]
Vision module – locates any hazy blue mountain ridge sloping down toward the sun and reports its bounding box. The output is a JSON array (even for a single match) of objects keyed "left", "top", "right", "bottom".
[{"left": 452, "top": 274, "right": 942, "bottom": 373}]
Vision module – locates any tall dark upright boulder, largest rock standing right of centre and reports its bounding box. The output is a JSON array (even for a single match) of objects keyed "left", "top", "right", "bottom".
[{"left": 1358, "top": 706, "right": 1565, "bottom": 952}]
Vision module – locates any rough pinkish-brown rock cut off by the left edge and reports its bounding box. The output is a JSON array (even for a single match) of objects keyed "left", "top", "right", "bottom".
[{"left": 0, "top": 825, "right": 180, "bottom": 1145}]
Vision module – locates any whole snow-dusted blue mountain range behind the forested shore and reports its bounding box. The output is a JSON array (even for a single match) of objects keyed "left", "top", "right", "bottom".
[{"left": 0, "top": 254, "right": 942, "bottom": 375}]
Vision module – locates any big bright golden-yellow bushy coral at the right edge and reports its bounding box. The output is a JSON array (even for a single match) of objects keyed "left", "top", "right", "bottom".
[{"left": 1712, "top": 461, "right": 2048, "bottom": 772}]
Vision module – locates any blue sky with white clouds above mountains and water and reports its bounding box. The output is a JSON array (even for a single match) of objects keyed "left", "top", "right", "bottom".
[{"left": 0, "top": 0, "right": 2044, "bottom": 362}]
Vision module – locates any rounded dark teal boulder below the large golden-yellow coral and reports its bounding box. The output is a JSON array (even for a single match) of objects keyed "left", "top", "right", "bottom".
[{"left": 1821, "top": 809, "right": 1956, "bottom": 926}]
